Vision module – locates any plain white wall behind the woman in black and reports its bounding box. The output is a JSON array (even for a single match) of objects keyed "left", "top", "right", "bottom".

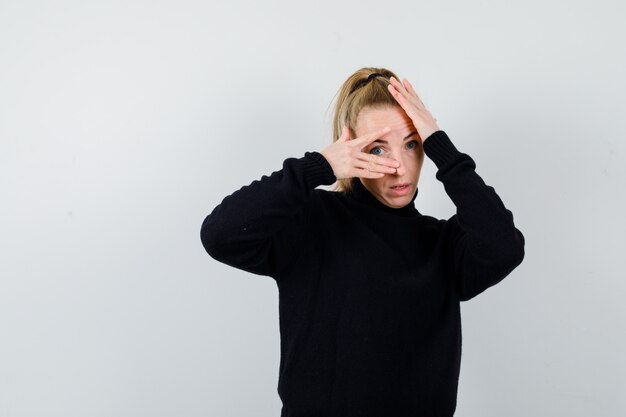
[{"left": 0, "top": 0, "right": 626, "bottom": 417}]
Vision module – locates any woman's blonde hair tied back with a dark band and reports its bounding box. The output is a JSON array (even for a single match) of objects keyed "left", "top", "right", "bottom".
[{"left": 331, "top": 67, "right": 400, "bottom": 192}]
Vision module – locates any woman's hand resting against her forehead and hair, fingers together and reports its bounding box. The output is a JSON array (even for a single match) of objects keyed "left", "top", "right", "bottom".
[{"left": 387, "top": 77, "right": 441, "bottom": 142}]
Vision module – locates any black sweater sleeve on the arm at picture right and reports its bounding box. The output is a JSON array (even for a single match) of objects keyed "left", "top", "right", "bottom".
[{"left": 423, "top": 130, "right": 525, "bottom": 301}]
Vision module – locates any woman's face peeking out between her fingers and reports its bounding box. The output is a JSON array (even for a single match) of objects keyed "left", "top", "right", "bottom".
[{"left": 354, "top": 106, "right": 424, "bottom": 208}]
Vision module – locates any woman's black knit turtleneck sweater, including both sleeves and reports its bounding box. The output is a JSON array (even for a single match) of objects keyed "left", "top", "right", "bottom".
[{"left": 201, "top": 130, "right": 524, "bottom": 417}]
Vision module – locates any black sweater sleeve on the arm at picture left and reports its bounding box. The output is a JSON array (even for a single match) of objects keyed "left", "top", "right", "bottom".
[{"left": 200, "top": 152, "right": 336, "bottom": 279}]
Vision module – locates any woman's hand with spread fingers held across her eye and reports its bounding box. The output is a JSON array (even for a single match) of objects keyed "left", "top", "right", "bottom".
[{"left": 320, "top": 126, "right": 400, "bottom": 180}]
